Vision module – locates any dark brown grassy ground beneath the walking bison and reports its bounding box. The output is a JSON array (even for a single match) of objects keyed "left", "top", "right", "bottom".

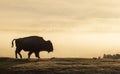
[{"left": 0, "top": 58, "right": 120, "bottom": 74}]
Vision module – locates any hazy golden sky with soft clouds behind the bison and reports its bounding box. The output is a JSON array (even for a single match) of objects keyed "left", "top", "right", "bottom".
[{"left": 0, "top": 0, "right": 120, "bottom": 57}]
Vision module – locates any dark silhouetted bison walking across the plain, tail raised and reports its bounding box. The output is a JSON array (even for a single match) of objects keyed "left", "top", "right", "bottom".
[{"left": 12, "top": 36, "right": 53, "bottom": 59}]
